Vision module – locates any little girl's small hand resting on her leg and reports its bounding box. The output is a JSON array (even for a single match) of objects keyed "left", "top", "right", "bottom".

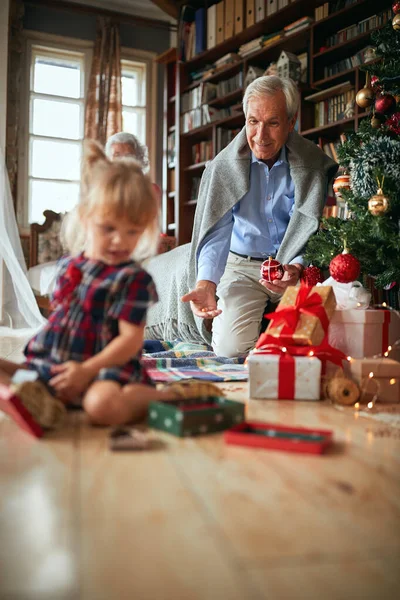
[{"left": 49, "top": 360, "right": 94, "bottom": 400}]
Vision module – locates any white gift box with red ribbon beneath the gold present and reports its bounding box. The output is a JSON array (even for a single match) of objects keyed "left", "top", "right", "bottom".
[{"left": 247, "top": 353, "right": 321, "bottom": 400}]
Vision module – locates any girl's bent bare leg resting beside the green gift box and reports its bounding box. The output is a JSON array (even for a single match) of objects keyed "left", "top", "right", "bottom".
[{"left": 83, "top": 381, "right": 209, "bottom": 425}]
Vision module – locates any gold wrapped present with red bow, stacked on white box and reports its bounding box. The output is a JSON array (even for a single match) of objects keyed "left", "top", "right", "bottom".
[{"left": 260, "top": 284, "right": 336, "bottom": 346}]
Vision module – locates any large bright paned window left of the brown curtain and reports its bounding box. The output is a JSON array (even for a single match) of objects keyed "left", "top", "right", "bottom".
[{"left": 26, "top": 44, "right": 85, "bottom": 223}]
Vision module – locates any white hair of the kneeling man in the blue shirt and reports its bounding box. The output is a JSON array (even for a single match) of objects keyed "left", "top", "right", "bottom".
[{"left": 243, "top": 75, "right": 299, "bottom": 119}]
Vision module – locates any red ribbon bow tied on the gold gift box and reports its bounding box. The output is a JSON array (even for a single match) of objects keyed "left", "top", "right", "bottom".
[{"left": 266, "top": 284, "right": 329, "bottom": 347}]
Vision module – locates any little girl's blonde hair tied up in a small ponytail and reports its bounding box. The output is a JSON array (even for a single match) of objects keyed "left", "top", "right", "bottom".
[{"left": 62, "top": 140, "right": 159, "bottom": 261}]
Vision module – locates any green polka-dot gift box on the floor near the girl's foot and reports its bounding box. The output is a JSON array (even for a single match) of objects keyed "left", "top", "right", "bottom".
[{"left": 148, "top": 396, "right": 245, "bottom": 437}]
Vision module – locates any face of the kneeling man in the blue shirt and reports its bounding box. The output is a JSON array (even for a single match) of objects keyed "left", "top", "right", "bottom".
[{"left": 246, "top": 91, "right": 297, "bottom": 163}]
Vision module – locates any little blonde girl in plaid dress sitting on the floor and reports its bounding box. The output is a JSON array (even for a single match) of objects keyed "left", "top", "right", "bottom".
[{"left": 0, "top": 142, "right": 220, "bottom": 427}]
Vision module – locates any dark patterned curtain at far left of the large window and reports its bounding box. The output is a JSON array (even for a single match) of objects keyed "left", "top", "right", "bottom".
[{"left": 5, "top": 0, "right": 24, "bottom": 206}]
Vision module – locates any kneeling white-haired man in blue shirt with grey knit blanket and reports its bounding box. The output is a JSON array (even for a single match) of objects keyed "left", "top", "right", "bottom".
[{"left": 147, "top": 76, "right": 337, "bottom": 356}]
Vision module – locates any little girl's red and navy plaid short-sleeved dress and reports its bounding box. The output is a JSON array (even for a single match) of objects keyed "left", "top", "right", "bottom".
[{"left": 24, "top": 255, "right": 158, "bottom": 385}]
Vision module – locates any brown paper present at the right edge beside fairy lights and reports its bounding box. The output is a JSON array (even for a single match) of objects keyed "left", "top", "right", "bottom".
[{"left": 346, "top": 358, "right": 400, "bottom": 402}]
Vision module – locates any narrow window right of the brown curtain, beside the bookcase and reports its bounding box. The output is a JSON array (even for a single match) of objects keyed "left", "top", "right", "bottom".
[{"left": 121, "top": 60, "right": 146, "bottom": 144}]
